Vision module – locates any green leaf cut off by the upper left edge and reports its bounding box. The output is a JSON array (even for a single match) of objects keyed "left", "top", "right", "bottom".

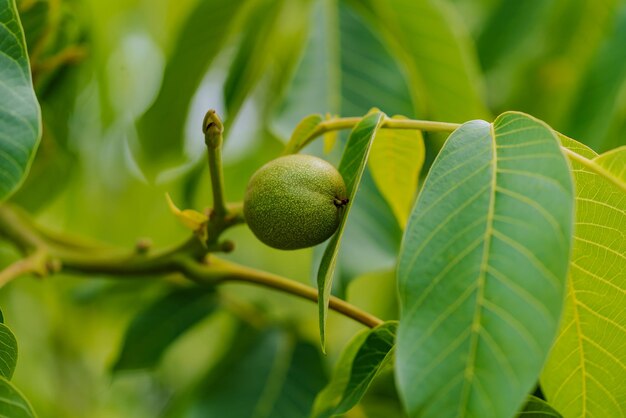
[{"left": 0, "top": 0, "right": 41, "bottom": 200}]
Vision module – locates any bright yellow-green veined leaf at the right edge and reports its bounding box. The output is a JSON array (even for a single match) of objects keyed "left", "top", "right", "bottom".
[{"left": 542, "top": 143, "right": 626, "bottom": 417}]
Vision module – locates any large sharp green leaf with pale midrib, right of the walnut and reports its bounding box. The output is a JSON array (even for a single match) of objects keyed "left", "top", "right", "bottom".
[{"left": 396, "top": 112, "right": 574, "bottom": 418}]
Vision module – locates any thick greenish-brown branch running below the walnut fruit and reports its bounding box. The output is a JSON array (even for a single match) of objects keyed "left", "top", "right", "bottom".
[{"left": 0, "top": 205, "right": 382, "bottom": 327}]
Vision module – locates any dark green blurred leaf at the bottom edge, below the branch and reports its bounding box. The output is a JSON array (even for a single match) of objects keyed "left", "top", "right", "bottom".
[{"left": 167, "top": 329, "right": 326, "bottom": 418}]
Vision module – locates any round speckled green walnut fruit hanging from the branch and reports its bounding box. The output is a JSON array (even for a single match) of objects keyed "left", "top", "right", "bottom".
[{"left": 243, "top": 154, "right": 348, "bottom": 250}]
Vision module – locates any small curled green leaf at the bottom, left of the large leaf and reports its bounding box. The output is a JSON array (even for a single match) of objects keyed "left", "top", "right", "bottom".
[{"left": 312, "top": 321, "right": 398, "bottom": 418}]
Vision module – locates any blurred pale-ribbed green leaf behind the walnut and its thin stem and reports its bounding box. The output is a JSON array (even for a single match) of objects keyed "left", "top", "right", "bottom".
[{"left": 272, "top": 0, "right": 404, "bottom": 296}]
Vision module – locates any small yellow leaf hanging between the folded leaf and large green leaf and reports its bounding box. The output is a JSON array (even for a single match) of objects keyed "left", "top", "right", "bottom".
[{"left": 369, "top": 116, "right": 425, "bottom": 228}]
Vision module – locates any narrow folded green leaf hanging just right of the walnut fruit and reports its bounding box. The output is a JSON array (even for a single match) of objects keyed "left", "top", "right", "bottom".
[{"left": 317, "top": 112, "right": 385, "bottom": 348}]
